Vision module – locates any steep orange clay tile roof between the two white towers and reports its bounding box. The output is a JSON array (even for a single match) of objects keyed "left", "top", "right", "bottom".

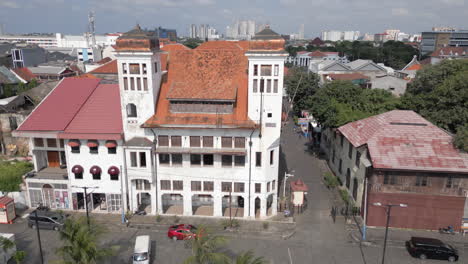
[{"left": 143, "top": 41, "right": 255, "bottom": 128}]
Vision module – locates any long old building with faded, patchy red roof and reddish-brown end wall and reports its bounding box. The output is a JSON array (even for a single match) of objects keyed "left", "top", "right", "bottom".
[{"left": 321, "top": 110, "right": 468, "bottom": 230}]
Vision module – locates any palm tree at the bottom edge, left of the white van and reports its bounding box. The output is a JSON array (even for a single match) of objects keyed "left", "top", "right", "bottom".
[{"left": 57, "top": 217, "right": 114, "bottom": 264}]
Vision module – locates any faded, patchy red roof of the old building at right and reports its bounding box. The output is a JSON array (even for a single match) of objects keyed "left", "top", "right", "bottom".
[{"left": 338, "top": 110, "right": 468, "bottom": 173}]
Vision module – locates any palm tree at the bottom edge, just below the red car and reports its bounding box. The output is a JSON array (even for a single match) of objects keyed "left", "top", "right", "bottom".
[{"left": 184, "top": 227, "right": 230, "bottom": 264}]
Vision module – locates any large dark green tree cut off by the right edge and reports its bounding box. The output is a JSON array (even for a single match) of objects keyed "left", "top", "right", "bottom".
[{"left": 402, "top": 60, "right": 468, "bottom": 150}]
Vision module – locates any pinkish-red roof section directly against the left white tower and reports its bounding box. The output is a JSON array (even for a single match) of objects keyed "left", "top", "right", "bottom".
[{"left": 59, "top": 84, "right": 123, "bottom": 139}]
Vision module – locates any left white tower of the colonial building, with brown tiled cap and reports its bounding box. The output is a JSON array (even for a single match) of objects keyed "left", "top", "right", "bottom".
[{"left": 114, "top": 25, "right": 162, "bottom": 140}]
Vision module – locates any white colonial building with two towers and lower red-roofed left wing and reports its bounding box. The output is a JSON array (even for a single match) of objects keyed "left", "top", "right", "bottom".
[{"left": 15, "top": 27, "right": 287, "bottom": 218}]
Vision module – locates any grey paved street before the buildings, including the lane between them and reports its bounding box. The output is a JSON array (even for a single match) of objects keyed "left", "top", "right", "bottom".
[{"left": 0, "top": 120, "right": 468, "bottom": 264}]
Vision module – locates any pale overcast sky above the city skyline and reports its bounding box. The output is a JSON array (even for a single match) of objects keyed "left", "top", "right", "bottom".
[{"left": 0, "top": 0, "right": 468, "bottom": 37}]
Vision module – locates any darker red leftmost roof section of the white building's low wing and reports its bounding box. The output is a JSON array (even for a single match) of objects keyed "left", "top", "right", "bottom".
[{"left": 17, "top": 78, "right": 99, "bottom": 132}]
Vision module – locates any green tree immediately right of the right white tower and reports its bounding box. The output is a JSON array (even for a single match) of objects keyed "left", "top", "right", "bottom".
[{"left": 284, "top": 67, "right": 319, "bottom": 114}]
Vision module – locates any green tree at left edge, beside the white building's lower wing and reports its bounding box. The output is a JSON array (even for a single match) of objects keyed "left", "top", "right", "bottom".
[{"left": 0, "top": 161, "right": 33, "bottom": 192}]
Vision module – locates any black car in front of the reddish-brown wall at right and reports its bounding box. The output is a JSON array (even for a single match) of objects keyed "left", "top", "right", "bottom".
[{"left": 406, "top": 237, "right": 458, "bottom": 262}]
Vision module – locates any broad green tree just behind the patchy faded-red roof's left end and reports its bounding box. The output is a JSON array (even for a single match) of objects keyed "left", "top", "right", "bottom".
[{"left": 307, "top": 81, "right": 399, "bottom": 127}]
